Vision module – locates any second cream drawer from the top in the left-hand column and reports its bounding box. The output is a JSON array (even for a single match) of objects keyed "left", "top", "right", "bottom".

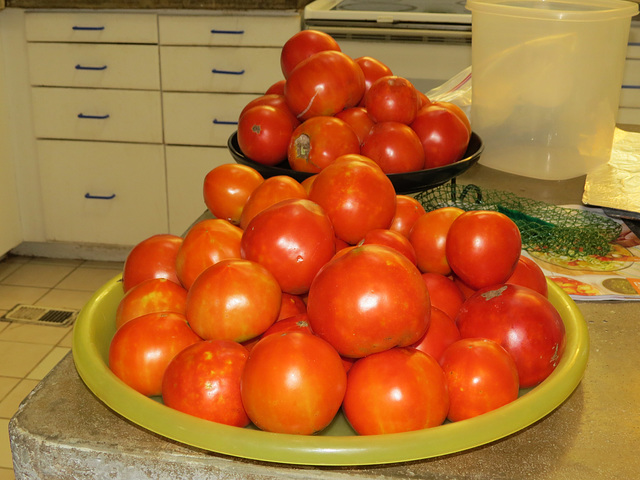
[{"left": 27, "top": 43, "right": 160, "bottom": 90}]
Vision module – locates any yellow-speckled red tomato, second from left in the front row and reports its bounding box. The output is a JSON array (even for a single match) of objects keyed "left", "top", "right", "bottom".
[{"left": 162, "top": 340, "right": 249, "bottom": 427}]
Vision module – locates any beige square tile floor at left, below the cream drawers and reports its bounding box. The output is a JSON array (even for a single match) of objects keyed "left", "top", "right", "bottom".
[{"left": 0, "top": 256, "right": 123, "bottom": 480}]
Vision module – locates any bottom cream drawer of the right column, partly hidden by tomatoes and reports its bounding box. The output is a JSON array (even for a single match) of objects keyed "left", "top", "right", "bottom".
[{"left": 165, "top": 145, "right": 233, "bottom": 235}]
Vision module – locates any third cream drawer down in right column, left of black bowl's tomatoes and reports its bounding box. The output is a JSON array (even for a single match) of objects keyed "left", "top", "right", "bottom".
[{"left": 162, "top": 92, "right": 256, "bottom": 147}]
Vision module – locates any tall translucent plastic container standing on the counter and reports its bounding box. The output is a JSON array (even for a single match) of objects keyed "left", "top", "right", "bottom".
[{"left": 466, "top": 0, "right": 638, "bottom": 180}]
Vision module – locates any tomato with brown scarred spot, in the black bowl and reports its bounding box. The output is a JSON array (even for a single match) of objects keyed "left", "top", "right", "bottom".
[{"left": 287, "top": 116, "right": 360, "bottom": 173}]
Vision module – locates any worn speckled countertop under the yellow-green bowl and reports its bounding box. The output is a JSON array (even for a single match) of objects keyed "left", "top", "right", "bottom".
[{"left": 9, "top": 165, "right": 640, "bottom": 480}]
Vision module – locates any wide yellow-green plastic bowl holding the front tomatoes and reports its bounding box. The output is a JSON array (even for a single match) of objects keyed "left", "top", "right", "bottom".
[{"left": 73, "top": 276, "right": 589, "bottom": 466}]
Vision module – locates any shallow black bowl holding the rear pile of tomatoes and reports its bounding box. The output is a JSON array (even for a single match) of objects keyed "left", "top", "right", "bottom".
[{"left": 227, "top": 132, "right": 484, "bottom": 194}]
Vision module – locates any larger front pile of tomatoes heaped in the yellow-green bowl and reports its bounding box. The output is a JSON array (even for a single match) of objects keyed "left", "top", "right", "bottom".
[{"left": 109, "top": 156, "right": 565, "bottom": 435}]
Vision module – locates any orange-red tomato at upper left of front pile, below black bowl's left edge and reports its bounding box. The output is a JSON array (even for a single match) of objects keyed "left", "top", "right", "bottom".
[{"left": 203, "top": 163, "right": 264, "bottom": 225}]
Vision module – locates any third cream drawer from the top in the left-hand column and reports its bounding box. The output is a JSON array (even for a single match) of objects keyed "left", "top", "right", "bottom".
[{"left": 32, "top": 87, "right": 162, "bottom": 143}]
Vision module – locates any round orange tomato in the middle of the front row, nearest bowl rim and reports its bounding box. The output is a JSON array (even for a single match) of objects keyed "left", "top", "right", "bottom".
[{"left": 241, "top": 332, "right": 347, "bottom": 435}]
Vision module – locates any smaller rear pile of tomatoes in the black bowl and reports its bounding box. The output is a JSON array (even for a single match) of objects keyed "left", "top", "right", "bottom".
[{"left": 238, "top": 30, "right": 471, "bottom": 174}]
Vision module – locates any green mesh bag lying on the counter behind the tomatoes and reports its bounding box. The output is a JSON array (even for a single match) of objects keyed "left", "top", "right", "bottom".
[{"left": 415, "top": 183, "right": 622, "bottom": 258}]
